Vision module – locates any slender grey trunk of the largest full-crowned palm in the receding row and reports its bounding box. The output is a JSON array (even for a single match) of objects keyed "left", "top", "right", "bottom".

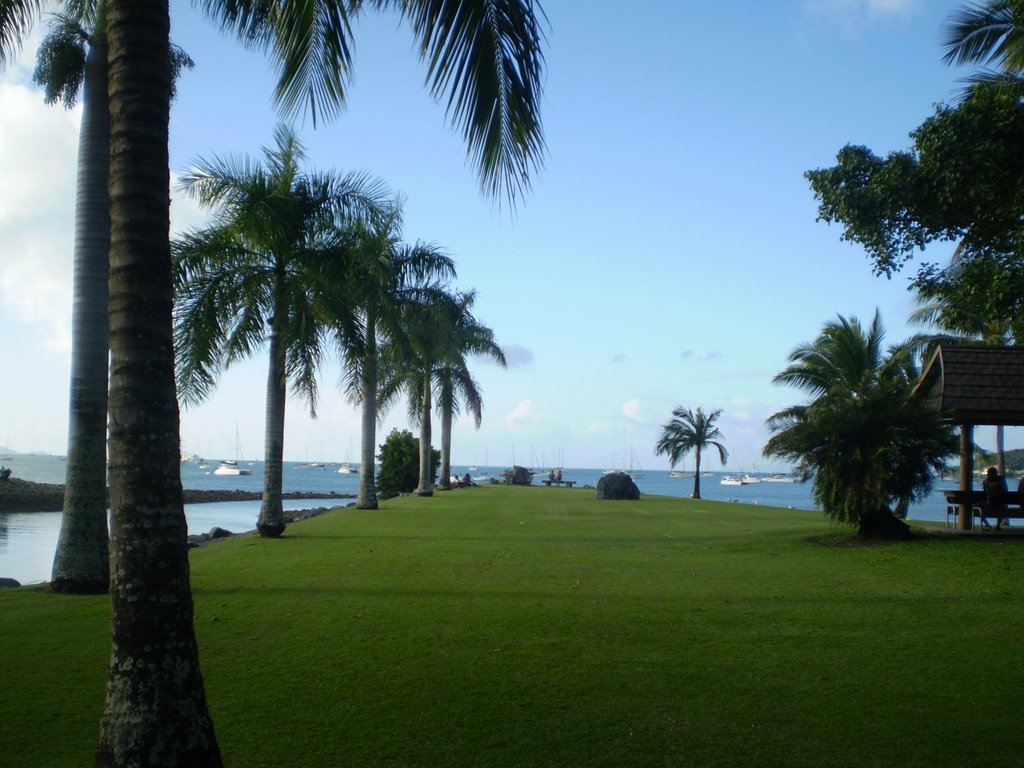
[{"left": 256, "top": 312, "right": 288, "bottom": 537}]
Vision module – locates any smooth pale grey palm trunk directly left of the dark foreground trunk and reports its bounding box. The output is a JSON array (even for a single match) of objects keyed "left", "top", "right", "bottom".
[{"left": 51, "top": 29, "right": 111, "bottom": 594}]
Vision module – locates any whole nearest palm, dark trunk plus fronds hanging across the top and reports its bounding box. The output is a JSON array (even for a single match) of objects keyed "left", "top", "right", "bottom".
[{"left": 0, "top": 0, "right": 544, "bottom": 757}]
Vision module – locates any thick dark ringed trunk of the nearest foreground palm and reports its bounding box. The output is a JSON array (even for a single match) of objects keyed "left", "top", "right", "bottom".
[{"left": 96, "top": 0, "right": 222, "bottom": 768}]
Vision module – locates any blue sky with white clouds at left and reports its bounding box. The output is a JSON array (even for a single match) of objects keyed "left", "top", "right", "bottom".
[{"left": 0, "top": 0, "right": 1020, "bottom": 471}]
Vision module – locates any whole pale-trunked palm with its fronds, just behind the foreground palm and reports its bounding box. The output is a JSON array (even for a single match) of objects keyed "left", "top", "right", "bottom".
[{"left": 33, "top": 0, "right": 193, "bottom": 593}]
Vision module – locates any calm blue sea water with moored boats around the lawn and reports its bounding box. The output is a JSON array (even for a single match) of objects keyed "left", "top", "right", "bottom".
[{"left": 0, "top": 454, "right": 949, "bottom": 584}]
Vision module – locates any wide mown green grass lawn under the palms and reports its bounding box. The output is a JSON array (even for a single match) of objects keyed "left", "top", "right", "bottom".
[{"left": 0, "top": 486, "right": 1024, "bottom": 768}]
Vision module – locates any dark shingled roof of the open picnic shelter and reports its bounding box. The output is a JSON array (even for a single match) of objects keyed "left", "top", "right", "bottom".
[{"left": 918, "top": 344, "right": 1024, "bottom": 426}]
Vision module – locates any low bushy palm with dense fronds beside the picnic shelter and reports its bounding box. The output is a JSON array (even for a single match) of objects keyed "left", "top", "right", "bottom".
[{"left": 764, "top": 312, "right": 958, "bottom": 538}]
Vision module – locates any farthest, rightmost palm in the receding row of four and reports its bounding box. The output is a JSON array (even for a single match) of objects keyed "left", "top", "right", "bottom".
[{"left": 434, "top": 291, "right": 508, "bottom": 490}]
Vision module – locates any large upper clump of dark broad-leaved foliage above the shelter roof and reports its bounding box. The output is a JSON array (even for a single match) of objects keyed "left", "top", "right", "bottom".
[{"left": 805, "top": 86, "right": 1024, "bottom": 276}]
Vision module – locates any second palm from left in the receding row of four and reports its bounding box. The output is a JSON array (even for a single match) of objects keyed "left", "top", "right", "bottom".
[{"left": 338, "top": 207, "right": 455, "bottom": 509}]
